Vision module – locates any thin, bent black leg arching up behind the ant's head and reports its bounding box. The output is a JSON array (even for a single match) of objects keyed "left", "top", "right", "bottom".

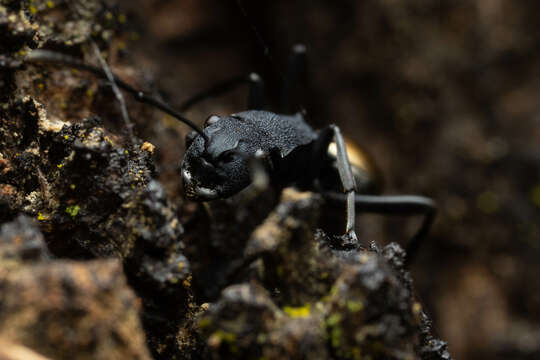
[{"left": 180, "top": 73, "right": 264, "bottom": 112}]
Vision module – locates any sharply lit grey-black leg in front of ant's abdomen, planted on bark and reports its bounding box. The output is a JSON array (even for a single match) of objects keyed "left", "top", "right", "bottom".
[{"left": 329, "top": 125, "right": 358, "bottom": 242}]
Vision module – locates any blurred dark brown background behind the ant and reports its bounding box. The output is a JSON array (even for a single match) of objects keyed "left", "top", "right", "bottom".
[{"left": 115, "top": 0, "right": 540, "bottom": 359}]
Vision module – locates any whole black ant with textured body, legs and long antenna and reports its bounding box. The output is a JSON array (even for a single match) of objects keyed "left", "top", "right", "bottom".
[{"left": 27, "top": 45, "right": 436, "bottom": 261}]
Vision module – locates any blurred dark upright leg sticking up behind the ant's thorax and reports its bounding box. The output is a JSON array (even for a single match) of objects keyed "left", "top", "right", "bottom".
[{"left": 280, "top": 44, "right": 307, "bottom": 114}]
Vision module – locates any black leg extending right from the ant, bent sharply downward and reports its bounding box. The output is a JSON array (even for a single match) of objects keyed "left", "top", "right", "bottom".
[{"left": 324, "top": 193, "right": 437, "bottom": 265}]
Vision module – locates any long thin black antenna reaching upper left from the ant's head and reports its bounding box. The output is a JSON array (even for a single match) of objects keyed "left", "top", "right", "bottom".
[{"left": 26, "top": 49, "right": 208, "bottom": 143}]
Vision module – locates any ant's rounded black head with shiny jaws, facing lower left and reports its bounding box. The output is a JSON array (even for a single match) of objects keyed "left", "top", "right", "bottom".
[{"left": 182, "top": 115, "right": 256, "bottom": 201}]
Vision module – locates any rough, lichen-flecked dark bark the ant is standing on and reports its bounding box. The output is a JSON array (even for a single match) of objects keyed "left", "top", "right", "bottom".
[{"left": 0, "top": 0, "right": 450, "bottom": 359}]
